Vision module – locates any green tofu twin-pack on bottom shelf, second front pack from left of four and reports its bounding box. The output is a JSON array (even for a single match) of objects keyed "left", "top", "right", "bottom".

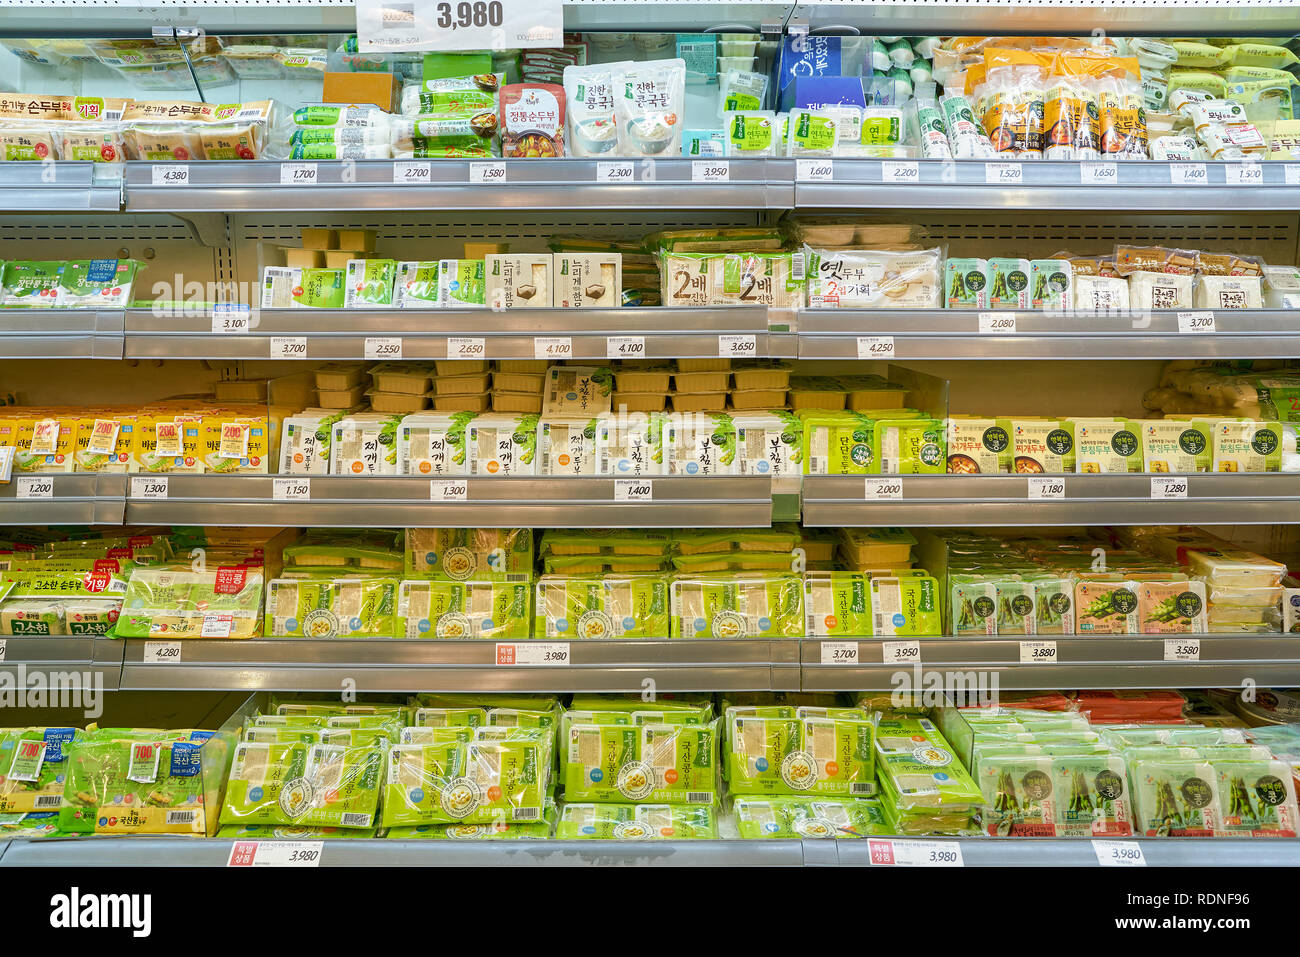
[{"left": 382, "top": 728, "right": 551, "bottom": 827}]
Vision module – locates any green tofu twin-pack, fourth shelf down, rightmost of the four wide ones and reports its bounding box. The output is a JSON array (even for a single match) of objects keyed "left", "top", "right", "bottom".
[{"left": 671, "top": 575, "right": 803, "bottom": 638}]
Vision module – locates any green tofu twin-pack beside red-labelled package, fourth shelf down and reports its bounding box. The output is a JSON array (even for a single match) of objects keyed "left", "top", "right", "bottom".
[{"left": 264, "top": 577, "right": 398, "bottom": 638}]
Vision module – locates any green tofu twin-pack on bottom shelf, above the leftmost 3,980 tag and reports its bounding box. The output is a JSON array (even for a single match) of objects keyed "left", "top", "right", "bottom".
[{"left": 221, "top": 741, "right": 384, "bottom": 828}]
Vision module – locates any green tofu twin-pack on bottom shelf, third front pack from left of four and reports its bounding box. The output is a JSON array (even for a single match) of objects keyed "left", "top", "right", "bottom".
[{"left": 560, "top": 718, "right": 718, "bottom": 805}]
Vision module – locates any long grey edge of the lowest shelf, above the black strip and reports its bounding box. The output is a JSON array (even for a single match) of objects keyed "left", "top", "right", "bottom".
[{"left": 0, "top": 837, "right": 1300, "bottom": 870}]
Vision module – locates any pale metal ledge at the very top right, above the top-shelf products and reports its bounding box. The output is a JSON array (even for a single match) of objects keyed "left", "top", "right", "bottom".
[{"left": 793, "top": 0, "right": 1295, "bottom": 36}]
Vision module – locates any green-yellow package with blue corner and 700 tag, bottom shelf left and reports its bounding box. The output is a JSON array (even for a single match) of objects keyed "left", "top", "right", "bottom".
[{"left": 59, "top": 732, "right": 209, "bottom": 836}]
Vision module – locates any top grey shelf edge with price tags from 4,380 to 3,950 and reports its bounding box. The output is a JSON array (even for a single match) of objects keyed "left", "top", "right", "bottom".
[{"left": 125, "top": 157, "right": 794, "bottom": 213}]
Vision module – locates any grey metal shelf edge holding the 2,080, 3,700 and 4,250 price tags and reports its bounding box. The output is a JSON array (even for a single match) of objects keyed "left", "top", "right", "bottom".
[{"left": 798, "top": 309, "right": 1300, "bottom": 359}]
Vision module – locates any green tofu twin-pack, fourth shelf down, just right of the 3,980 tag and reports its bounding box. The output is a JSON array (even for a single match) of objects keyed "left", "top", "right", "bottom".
[{"left": 533, "top": 573, "right": 671, "bottom": 638}]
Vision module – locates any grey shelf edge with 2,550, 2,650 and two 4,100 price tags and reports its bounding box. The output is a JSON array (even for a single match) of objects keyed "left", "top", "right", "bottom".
[{"left": 124, "top": 307, "right": 769, "bottom": 361}]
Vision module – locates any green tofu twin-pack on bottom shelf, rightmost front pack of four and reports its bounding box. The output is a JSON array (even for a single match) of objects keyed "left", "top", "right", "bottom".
[{"left": 724, "top": 706, "right": 876, "bottom": 797}]
